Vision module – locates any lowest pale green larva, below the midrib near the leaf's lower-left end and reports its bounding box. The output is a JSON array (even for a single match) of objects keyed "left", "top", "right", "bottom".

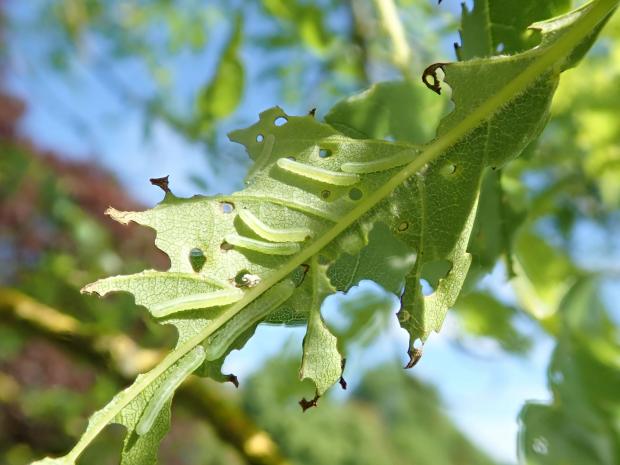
[{"left": 136, "top": 346, "right": 206, "bottom": 436}]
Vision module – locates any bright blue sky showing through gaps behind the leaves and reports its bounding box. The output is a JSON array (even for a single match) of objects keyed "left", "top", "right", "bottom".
[{"left": 7, "top": 0, "right": 552, "bottom": 463}]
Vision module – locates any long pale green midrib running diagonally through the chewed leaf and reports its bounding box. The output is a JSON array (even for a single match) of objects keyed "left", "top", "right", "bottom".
[{"left": 67, "top": 0, "right": 620, "bottom": 460}]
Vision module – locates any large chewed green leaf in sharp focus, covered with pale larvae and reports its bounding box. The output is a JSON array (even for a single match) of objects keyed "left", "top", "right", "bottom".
[{"left": 35, "top": 0, "right": 618, "bottom": 463}]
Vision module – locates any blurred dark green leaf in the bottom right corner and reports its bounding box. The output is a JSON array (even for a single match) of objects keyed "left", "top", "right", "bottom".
[{"left": 519, "top": 278, "right": 620, "bottom": 465}]
